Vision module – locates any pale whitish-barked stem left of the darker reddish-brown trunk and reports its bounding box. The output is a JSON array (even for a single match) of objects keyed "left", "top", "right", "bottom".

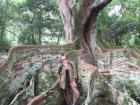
[{"left": 58, "top": 0, "right": 74, "bottom": 43}]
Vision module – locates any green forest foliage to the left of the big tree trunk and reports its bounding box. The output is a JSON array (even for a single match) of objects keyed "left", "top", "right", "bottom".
[{"left": 0, "top": 0, "right": 64, "bottom": 46}]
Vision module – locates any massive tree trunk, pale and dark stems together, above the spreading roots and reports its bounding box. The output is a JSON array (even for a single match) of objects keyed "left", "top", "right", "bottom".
[{"left": 59, "top": 0, "right": 111, "bottom": 65}]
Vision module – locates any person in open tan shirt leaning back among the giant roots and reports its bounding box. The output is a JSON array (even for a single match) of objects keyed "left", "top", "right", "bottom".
[{"left": 58, "top": 54, "right": 80, "bottom": 105}]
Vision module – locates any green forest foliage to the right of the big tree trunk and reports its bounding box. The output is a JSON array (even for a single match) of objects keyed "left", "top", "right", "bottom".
[{"left": 97, "top": 0, "right": 140, "bottom": 47}]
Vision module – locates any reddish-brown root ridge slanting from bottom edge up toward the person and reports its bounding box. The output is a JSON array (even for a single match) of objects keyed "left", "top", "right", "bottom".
[{"left": 27, "top": 80, "right": 59, "bottom": 105}]
